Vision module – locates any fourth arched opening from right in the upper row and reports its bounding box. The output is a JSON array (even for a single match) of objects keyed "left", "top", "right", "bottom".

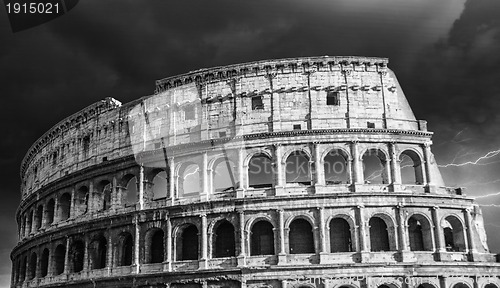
[{"left": 285, "top": 151, "right": 311, "bottom": 185}]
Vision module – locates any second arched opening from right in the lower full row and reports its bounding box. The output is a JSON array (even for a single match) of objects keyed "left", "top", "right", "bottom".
[{"left": 408, "top": 215, "right": 432, "bottom": 251}]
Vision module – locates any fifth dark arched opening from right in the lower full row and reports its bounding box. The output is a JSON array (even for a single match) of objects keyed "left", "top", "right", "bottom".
[{"left": 289, "top": 219, "right": 314, "bottom": 254}]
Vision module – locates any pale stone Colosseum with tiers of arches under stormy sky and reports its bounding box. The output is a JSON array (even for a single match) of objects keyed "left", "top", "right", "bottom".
[{"left": 11, "top": 56, "right": 500, "bottom": 288}]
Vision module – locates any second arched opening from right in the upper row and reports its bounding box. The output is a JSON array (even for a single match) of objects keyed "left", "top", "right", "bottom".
[{"left": 363, "top": 149, "right": 389, "bottom": 184}]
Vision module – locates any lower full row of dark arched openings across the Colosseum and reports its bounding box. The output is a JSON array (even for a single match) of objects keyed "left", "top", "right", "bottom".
[{"left": 16, "top": 208, "right": 465, "bottom": 281}]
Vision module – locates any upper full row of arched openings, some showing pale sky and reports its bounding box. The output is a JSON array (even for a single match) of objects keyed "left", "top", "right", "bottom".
[{"left": 19, "top": 149, "right": 423, "bottom": 238}]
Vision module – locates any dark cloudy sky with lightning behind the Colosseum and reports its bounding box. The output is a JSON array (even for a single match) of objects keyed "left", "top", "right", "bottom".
[{"left": 0, "top": 0, "right": 500, "bottom": 287}]
